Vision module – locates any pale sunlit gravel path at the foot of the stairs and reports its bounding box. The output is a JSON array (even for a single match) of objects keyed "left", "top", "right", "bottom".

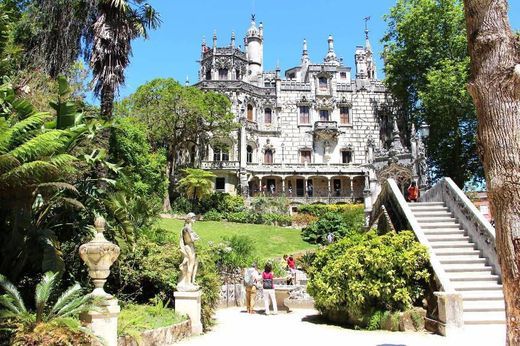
[{"left": 179, "top": 308, "right": 505, "bottom": 346}]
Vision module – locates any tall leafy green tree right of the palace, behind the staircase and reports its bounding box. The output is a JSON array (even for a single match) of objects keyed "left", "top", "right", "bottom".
[{"left": 383, "top": 0, "right": 482, "bottom": 186}]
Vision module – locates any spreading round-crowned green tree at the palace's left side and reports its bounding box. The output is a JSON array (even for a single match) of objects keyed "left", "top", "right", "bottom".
[{"left": 116, "top": 78, "right": 236, "bottom": 209}]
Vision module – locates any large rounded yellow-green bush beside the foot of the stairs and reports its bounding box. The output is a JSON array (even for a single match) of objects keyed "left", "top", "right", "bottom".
[{"left": 307, "top": 230, "right": 430, "bottom": 326}]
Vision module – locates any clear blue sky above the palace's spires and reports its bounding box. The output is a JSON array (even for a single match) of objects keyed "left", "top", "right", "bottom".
[{"left": 114, "top": 0, "right": 520, "bottom": 98}]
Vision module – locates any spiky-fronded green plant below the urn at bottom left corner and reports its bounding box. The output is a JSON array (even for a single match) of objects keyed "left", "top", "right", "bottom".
[{"left": 0, "top": 272, "right": 97, "bottom": 345}]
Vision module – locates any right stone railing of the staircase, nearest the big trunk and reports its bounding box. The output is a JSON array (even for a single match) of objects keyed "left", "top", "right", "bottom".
[{"left": 420, "top": 178, "right": 501, "bottom": 277}]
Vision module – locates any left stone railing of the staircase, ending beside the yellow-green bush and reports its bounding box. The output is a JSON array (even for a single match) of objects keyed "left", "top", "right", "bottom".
[{"left": 369, "top": 179, "right": 464, "bottom": 335}]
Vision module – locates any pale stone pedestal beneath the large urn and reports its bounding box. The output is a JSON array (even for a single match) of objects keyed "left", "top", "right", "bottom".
[{"left": 80, "top": 299, "right": 121, "bottom": 346}]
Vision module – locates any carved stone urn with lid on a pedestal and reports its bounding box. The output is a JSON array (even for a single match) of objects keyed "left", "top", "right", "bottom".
[{"left": 79, "top": 217, "right": 120, "bottom": 299}]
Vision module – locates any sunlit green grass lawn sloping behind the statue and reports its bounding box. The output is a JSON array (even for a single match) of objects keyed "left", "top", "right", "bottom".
[{"left": 158, "top": 219, "right": 317, "bottom": 259}]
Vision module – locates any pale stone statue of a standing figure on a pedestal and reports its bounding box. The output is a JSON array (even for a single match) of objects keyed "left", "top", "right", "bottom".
[{"left": 177, "top": 213, "right": 199, "bottom": 292}]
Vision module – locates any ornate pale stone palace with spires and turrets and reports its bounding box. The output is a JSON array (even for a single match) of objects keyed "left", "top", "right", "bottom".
[{"left": 196, "top": 16, "right": 424, "bottom": 215}]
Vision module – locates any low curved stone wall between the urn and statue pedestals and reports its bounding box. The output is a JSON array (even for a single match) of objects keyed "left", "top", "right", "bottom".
[{"left": 117, "top": 320, "right": 191, "bottom": 346}]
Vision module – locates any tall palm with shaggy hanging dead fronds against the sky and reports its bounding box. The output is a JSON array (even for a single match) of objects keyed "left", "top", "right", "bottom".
[{"left": 90, "top": 0, "right": 160, "bottom": 119}]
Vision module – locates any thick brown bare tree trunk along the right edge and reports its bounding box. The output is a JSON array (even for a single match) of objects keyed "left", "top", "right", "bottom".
[{"left": 464, "top": 0, "right": 520, "bottom": 345}]
